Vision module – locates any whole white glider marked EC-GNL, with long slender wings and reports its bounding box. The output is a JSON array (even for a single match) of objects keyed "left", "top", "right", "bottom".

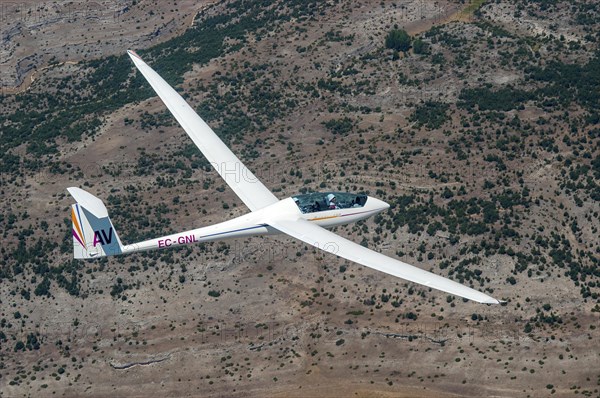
[{"left": 67, "top": 51, "right": 499, "bottom": 304}]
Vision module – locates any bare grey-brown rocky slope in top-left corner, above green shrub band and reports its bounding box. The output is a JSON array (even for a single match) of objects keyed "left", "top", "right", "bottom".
[{"left": 0, "top": 0, "right": 214, "bottom": 94}]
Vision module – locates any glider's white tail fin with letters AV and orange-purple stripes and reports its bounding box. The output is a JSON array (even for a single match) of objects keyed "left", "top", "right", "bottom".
[{"left": 67, "top": 187, "right": 123, "bottom": 258}]
